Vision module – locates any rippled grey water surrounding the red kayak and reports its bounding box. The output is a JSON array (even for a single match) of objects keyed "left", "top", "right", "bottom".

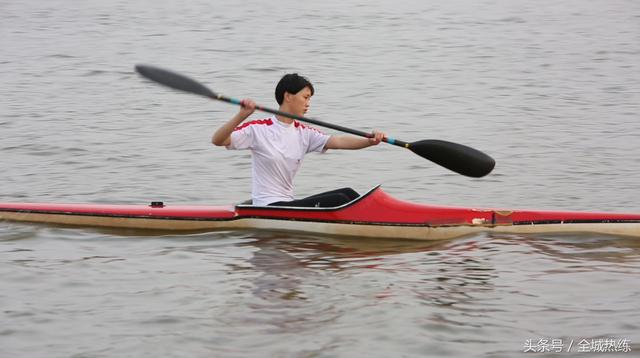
[{"left": 0, "top": 0, "right": 640, "bottom": 357}]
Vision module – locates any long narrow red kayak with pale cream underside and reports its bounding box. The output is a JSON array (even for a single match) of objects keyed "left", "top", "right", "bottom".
[{"left": 0, "top": 186, "right": 640, "bottom": 240}]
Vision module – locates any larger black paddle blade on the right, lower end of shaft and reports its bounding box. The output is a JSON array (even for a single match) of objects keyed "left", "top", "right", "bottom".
[{"left": 409, "top": 139, "right": 496, "bottom": 178}]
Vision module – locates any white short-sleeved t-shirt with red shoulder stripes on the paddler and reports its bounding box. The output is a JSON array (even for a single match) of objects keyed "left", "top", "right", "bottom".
[{"left": 227, "top": 116, "right": 330, "bottom": 205}]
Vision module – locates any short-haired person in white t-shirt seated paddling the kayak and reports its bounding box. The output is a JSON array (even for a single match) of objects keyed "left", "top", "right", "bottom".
[{"left": 211, "top": 73, "right": 384, "bottom": 207}]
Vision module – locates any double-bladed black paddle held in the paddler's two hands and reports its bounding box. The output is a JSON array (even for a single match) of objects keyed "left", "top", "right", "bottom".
[{"left": 136, "top": 65, "right": 496, "bottom": 178}]
